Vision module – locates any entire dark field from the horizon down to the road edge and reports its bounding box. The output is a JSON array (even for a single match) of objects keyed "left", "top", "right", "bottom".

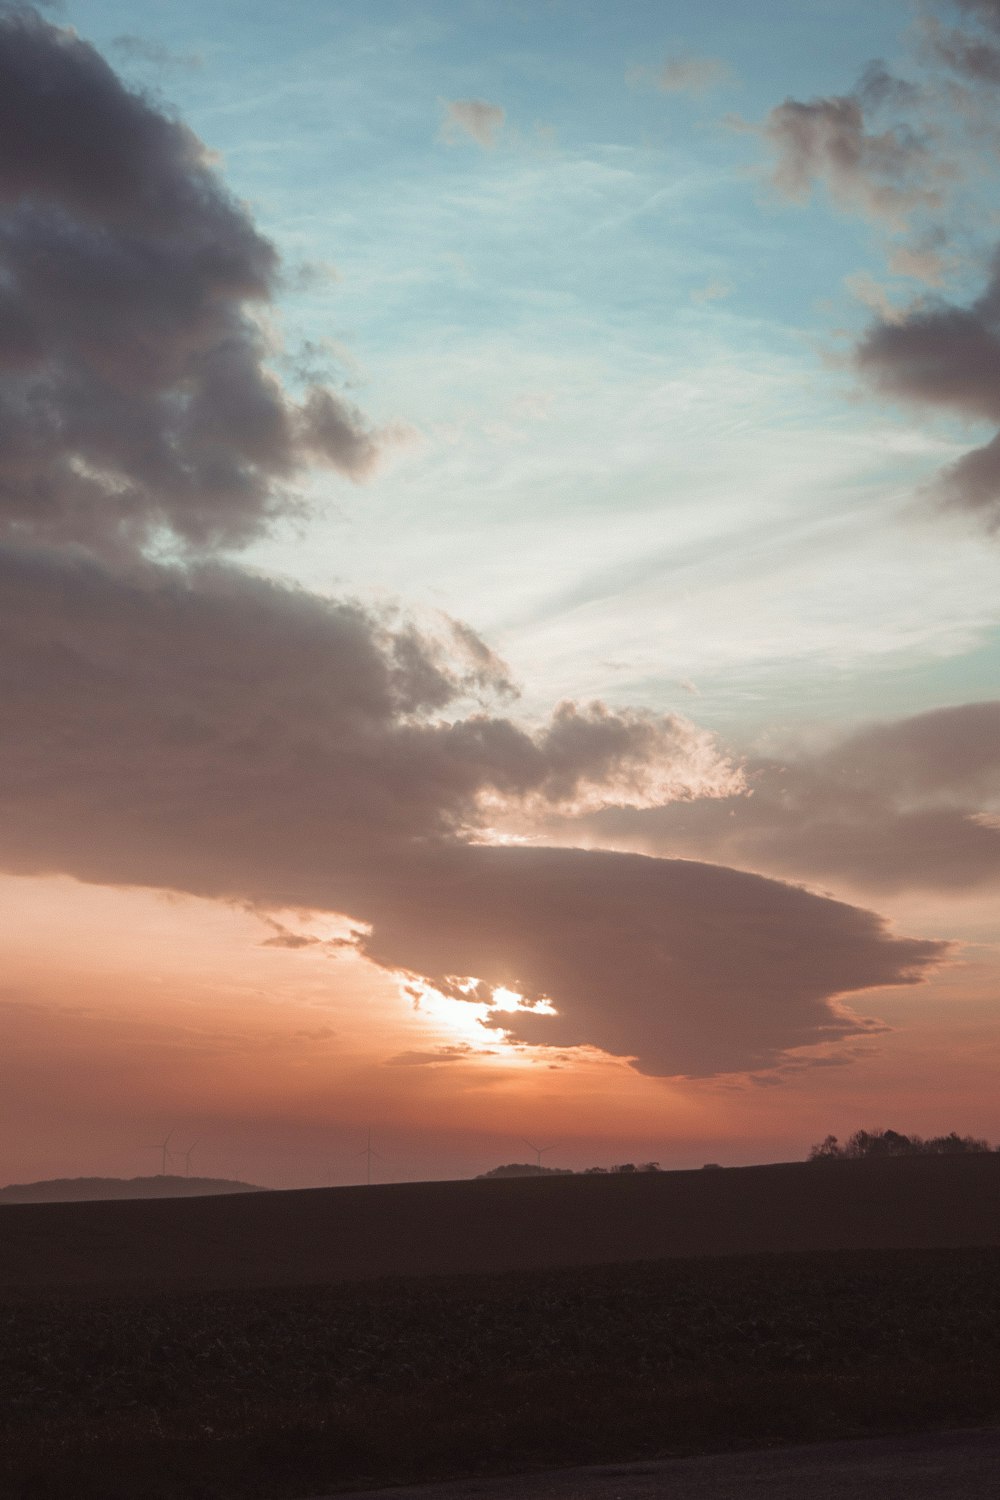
[{"left": 0, "top": 1157, "right": 1000, "bottom": 1500}]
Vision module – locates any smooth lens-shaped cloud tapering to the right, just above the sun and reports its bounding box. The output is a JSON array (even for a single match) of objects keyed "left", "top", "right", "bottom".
[{"left": 363, "top": 846, "right": 946, "bottom": 1077}]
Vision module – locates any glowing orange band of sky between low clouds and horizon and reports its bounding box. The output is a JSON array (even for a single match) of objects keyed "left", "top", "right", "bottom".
[{"left": 0, "top": 878, "right": 1000, "bottom": 1187}]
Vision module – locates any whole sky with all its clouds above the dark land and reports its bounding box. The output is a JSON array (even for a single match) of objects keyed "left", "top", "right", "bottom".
[{"left": 0, "top": 0, "right": 1000, "bottom": 1187}]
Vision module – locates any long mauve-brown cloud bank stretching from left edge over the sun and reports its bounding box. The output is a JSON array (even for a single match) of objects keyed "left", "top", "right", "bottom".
[{"left": 0, "top": 552, "right": 943, "bottom": 1074}]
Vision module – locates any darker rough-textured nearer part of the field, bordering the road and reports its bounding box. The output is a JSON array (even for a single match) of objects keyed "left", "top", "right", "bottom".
[{"left": 0, "top": 1250, "right": 1000, "bottom": 1500}]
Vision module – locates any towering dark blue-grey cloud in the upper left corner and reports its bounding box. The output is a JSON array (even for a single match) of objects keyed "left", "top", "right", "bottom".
[{"left": 0, "top": 11, "right": 388, "bottom": 554}]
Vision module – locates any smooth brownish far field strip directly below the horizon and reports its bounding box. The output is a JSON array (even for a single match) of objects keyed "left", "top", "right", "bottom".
[{"left": 0, "top": 1155, "right": 1000, "bottom": 1296}]
